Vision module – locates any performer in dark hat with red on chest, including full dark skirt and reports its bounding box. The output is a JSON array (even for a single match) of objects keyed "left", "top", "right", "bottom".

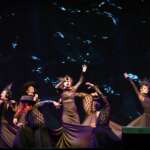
[{"left": 13, "top": 82, "right": 51, "bottom": 148}]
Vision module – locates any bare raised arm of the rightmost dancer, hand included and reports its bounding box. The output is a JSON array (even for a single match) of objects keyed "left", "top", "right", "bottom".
[{"left": 124, "top": 73, "right": 144, "bottom": 101}]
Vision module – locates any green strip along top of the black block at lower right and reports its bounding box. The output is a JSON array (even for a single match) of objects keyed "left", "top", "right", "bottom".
[{"left": 122, "top": 127, "right": 150, "bottom": 134}]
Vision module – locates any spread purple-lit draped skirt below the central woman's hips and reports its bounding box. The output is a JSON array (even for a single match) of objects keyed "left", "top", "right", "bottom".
[{"left": 56, "top": 123, "right": 94, "bottom": 148}]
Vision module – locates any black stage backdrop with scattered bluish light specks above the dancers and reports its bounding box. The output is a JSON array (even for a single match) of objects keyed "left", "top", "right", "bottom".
[{"left": 0, "top": 0, "right": 150, "bottom": 125}]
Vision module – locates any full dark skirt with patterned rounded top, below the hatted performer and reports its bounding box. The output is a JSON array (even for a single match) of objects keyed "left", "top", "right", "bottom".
[{"left": 13, "top": 109, "right": 51, "bottom": 148}]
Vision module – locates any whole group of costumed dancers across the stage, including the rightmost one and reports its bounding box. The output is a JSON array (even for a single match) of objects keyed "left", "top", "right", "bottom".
[{"left": 0, "top": 65, "right": 150, "bottom": 148}]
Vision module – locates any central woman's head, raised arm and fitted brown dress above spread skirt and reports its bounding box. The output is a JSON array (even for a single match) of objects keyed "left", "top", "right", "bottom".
[{"left": 55, "top": 65, "right": 87, "bottom": 124}]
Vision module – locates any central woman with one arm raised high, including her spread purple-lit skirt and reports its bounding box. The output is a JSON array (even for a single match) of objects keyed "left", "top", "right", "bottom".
[{"left": 53, "top": 65, "right": 92, "bottom": 148}]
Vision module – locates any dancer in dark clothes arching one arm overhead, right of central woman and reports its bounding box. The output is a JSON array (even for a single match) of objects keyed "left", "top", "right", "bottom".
[{"left": 80, "top": 82, "right": 122, "bottom": 148}]
